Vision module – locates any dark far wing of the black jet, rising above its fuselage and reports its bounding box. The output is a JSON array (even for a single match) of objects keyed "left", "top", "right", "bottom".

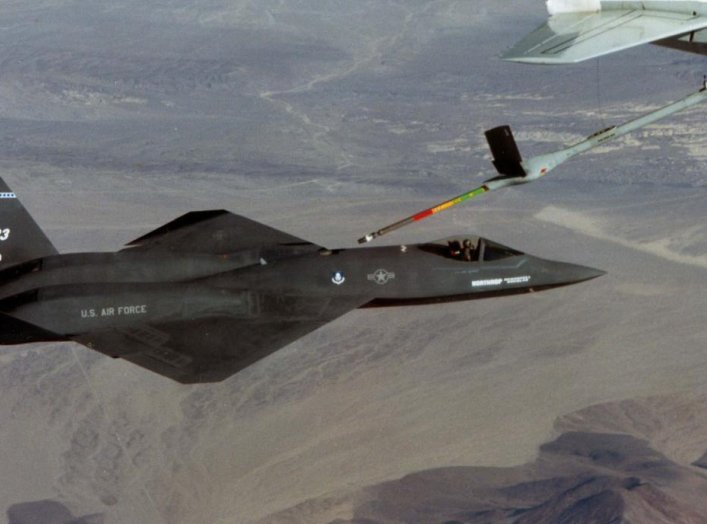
[{"left": 128, "top": 209, "right": 318, "bottom": 254}]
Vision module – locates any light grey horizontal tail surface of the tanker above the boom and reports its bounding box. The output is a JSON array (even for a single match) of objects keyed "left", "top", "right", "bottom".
[{"left": 502, "top": 9, "right": 707, "bottom": 64}]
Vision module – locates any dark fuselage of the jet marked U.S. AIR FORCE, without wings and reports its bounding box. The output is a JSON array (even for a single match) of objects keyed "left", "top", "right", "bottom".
[{"left": 0, "top": 241, "right": 602, "bottom": 337}]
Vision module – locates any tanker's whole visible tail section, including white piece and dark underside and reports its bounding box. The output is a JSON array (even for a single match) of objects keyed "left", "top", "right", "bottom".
[{"left": 503, "top": 0, "right": 707, "bottom": 64}]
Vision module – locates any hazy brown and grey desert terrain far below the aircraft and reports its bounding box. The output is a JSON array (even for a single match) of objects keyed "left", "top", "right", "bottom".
[{"left": 0, "top": 0, "right": 707, "bottom": 524}]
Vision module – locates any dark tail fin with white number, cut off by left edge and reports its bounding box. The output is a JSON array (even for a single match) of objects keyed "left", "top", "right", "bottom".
[{"left": 0, "top": 178, "right": 57, "bottom": 269}]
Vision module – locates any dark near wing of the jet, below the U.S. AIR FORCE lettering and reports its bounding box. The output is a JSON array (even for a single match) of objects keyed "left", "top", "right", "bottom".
[{"left": 72, "top": 295, "right": 371, "bottom": 384}]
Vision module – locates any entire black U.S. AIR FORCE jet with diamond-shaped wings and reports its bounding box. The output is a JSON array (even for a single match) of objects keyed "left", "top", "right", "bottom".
[{"left": 0, "top": 179, "right": 603, "bottom": 383}]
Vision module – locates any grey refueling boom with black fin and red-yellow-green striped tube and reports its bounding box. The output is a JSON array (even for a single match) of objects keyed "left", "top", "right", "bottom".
[{"left": 358, "top": 79, "right": 707, "bottom": 244}]
